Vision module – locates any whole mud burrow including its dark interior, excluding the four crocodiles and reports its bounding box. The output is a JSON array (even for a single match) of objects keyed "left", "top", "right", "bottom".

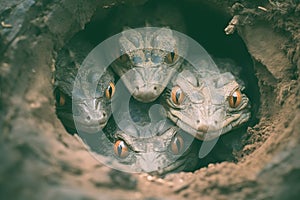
[{"left": 0, "top": 0, "right": 300, "bottom": 199}]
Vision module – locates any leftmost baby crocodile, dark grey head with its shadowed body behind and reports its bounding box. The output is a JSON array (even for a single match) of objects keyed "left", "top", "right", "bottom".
[{"left": 54, "top": 37, "right": 115, "bottom": 133}]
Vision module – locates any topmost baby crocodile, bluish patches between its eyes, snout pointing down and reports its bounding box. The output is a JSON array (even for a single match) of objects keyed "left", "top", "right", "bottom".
[{"left": 112, "top": 27, "right": 184, "bottom": 102}]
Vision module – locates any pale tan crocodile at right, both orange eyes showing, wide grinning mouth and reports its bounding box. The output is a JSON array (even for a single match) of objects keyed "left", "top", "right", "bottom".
[{"left": 165, "top": 58, "right": 250, "bottom": 140}]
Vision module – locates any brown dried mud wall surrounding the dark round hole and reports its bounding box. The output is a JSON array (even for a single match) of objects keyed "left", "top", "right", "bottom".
[{"left": 0, "top": 0, "right": 300, "bottom": 200}]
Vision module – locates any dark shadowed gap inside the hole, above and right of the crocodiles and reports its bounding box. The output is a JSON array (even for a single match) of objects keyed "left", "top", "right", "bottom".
[{"left": 56, "top": 0, "right": 260, "bottom": 172}]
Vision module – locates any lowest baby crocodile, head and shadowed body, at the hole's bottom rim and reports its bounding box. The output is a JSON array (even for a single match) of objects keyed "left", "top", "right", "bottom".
[{"left": 80, "top": 96, "right": 200, "bottom": 175}]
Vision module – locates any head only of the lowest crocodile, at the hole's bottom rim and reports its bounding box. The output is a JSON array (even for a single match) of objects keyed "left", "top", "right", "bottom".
[{"left": 113, "top": 126, "right": 199, "bottom": 175}]
